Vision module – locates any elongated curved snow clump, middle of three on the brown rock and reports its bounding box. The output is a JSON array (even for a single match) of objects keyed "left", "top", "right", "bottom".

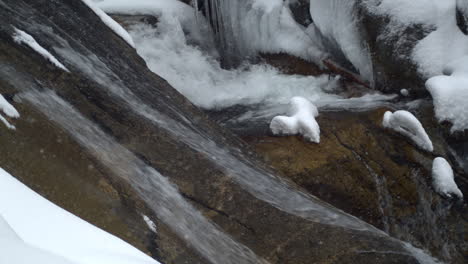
[{"left": 382, "top": 110, "right": 434, "bottom": 152}]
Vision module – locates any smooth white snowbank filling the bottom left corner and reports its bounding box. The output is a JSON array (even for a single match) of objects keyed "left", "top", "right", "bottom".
[{"left": 0, "top": 168, "right": 158, "bottom": 264}]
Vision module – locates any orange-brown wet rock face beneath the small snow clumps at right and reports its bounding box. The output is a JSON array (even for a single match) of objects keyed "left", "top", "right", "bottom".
[{"left": 237, "top": 105, "right": 468, "bottom": 263}]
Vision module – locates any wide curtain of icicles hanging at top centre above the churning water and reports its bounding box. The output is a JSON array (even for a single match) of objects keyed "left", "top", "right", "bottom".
[{"left": 194, "top": 0, "right": 326, "bottom": 67}]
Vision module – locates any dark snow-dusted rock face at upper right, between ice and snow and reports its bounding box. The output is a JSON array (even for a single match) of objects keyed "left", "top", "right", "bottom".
[{"left": 358, "top": 4, "right": 435, "bottom": 96}]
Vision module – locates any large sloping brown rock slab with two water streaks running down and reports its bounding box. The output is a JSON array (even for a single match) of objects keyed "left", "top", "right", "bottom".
[{"left": 0, "top": 0, "right": 442, "bottom": 264}]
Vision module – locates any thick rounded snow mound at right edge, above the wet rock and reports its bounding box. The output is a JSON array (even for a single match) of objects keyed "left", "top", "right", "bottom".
[{"left": 426, "top": 56, "right": 468, "bottom": 133}]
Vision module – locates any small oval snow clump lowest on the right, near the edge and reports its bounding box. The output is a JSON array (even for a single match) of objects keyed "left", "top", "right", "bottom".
[{"left": 432, "top": 157, "right": 463, "bottom": 199}]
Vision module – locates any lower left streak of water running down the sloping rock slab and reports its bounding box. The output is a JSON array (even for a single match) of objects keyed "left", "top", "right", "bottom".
[{"left": 19, "top": 90, "right": 267, "bottom": 264}]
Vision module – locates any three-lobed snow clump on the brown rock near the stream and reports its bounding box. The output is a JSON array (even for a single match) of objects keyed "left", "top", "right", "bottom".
[{"left": 270, "top": 97, "right": 320, "bottom": 143}]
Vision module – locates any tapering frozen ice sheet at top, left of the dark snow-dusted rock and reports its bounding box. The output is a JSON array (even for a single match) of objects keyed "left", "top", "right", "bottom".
[{"left": 310, "top": 0, "right": 374, "bottom": 83}]
